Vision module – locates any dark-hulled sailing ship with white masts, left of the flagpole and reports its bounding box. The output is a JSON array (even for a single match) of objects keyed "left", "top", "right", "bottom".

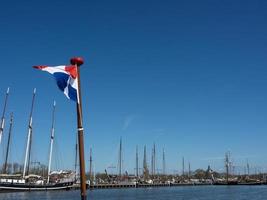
[{"left": 0, "top": 89, "right": 74, "bottom": 191}]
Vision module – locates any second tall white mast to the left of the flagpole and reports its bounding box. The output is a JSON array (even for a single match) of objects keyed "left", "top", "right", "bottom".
[{"left": 23, "top": 88, "right": 36, "bottom": 178}]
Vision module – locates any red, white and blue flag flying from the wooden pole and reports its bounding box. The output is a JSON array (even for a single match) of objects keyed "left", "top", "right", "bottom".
[{"left": 34, "top": 65, "right": 79, "bottom": 103}]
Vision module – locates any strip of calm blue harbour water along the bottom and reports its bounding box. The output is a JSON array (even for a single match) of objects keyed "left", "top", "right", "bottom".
[{"left": 0, "top": 186, "right": 267, "bottom": 200}]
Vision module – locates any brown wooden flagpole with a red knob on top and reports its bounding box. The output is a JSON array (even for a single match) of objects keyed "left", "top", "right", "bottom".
[{"left": 70, "top": 57, "right": 86, "bottom": 200}]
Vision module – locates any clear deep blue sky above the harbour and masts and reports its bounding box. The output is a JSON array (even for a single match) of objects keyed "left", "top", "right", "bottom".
[{"left": 0, "top": 0, "right": 267, "bottom": 172}]
